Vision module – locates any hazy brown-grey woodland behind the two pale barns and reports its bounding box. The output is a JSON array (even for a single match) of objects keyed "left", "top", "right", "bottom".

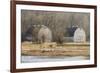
[{"left": 21, "top": 10, "right": 90, "bottom": 41}]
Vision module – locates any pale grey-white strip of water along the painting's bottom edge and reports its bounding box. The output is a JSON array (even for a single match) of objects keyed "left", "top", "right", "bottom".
[{"left": 21, "top": 56, "right": 89, "bottom": 63}]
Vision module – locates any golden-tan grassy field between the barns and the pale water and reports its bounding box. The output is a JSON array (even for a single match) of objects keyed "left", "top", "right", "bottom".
[{"left": 21, "top": 42, "right": 90, "bottom": 56}]
